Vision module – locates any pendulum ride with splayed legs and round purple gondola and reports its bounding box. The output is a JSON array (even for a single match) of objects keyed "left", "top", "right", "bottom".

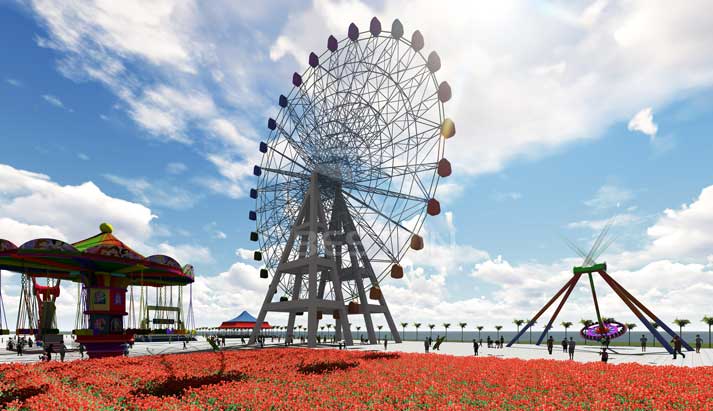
[{"left": 507, "top": 222, "right": 693, "bottom": 354}]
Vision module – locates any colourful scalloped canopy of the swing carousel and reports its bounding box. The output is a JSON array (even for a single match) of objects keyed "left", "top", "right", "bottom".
[{"left": 0, "top": 223, "right": 194, "bottom": 286}]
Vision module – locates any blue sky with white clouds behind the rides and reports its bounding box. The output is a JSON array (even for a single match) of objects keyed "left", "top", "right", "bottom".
[{"left": 0, "top": 0, "right": 713, "bottom": 332}]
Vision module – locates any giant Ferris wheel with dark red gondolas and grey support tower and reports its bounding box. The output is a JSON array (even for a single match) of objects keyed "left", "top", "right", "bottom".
[{"left": 249, "top": 18, "right": 455, "bottom": 347}]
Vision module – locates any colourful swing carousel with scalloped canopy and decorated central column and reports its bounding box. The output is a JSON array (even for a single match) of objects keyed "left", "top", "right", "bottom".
[{"left": 0, "top": 223, "right": 194, "bottom": 358}]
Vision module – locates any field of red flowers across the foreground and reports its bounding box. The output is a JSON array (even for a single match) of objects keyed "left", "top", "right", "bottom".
[{"left": 0, "top": 349, "right": 713, "bottom": 410}]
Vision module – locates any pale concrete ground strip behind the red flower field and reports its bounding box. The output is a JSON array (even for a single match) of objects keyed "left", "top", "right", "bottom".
[{"left": 0, "top": 337, "right": 713, "bottom": 367}]
